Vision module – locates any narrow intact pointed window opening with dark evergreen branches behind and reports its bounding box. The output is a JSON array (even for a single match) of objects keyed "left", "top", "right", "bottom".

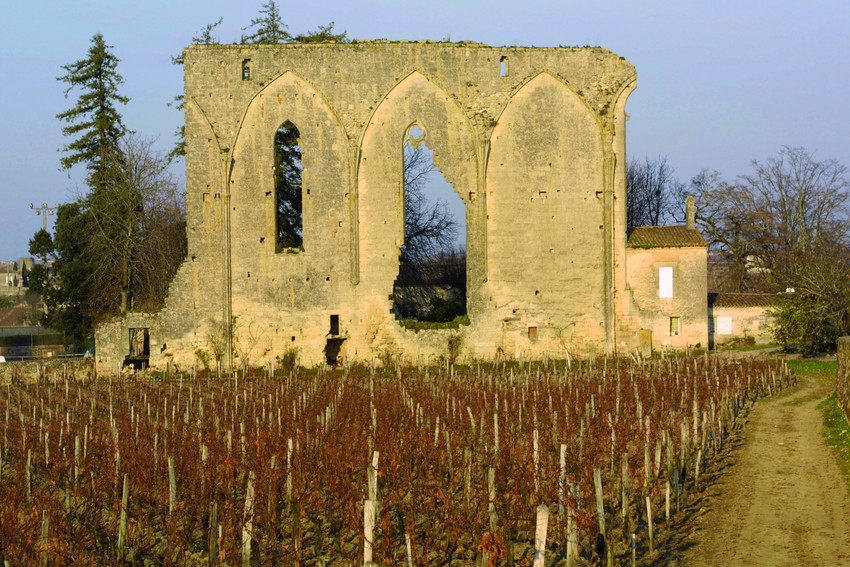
[{"left": 274, "top": 121, "right": 304, "bottom": 252}]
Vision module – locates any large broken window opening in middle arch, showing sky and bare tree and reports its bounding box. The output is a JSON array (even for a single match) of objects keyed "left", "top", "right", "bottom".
[{"left": 392, "top": 124, "right": 467, "bottom": 323}]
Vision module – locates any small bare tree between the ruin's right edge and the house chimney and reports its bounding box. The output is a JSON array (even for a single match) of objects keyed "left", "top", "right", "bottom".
[{"left": 626, "top": 157, "right": 679, "bottom": 232}]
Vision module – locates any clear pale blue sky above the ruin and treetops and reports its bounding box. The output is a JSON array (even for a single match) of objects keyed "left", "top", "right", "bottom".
[{"left": 0, "top": 0, "right": 850, "bottom": 260}]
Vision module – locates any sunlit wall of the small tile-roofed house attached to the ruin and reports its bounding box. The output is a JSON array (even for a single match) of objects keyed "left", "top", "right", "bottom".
[{"left": 626, "top": 247, "right": 708, "bottom": 349}]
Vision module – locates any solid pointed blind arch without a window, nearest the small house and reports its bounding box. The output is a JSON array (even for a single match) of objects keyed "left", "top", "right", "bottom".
[{"left": 480, "top": 73, "right": 605, "bottom": 336}]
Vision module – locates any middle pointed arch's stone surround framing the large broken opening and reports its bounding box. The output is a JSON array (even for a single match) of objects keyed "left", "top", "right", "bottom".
[{"left": 357, "top": 71, "right": 484, "bottom": 309}]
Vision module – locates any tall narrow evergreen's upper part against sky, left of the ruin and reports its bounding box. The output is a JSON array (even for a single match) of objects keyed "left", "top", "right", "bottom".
[{"left": 56, "top": 33, "right": 130, "bottom": 189}]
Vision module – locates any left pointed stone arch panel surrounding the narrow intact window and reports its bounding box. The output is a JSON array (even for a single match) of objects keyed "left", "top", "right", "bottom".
[{"left": 228, "top": 72, "right": 350, "bottom": 306}]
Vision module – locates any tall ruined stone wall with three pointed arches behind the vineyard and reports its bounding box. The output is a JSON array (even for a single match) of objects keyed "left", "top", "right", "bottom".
[{"left": 97, "top": 41, "right": 705, "bottom": 368}]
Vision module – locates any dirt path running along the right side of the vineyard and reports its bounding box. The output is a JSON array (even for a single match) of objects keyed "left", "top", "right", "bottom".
[{"left": 681, "top": 379, "right": 850, "bottom": 567}]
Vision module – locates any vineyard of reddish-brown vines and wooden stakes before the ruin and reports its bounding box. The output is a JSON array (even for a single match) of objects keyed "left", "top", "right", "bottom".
[{"left": 0, "top": 356, "right": 793, "bottom": 567}]
